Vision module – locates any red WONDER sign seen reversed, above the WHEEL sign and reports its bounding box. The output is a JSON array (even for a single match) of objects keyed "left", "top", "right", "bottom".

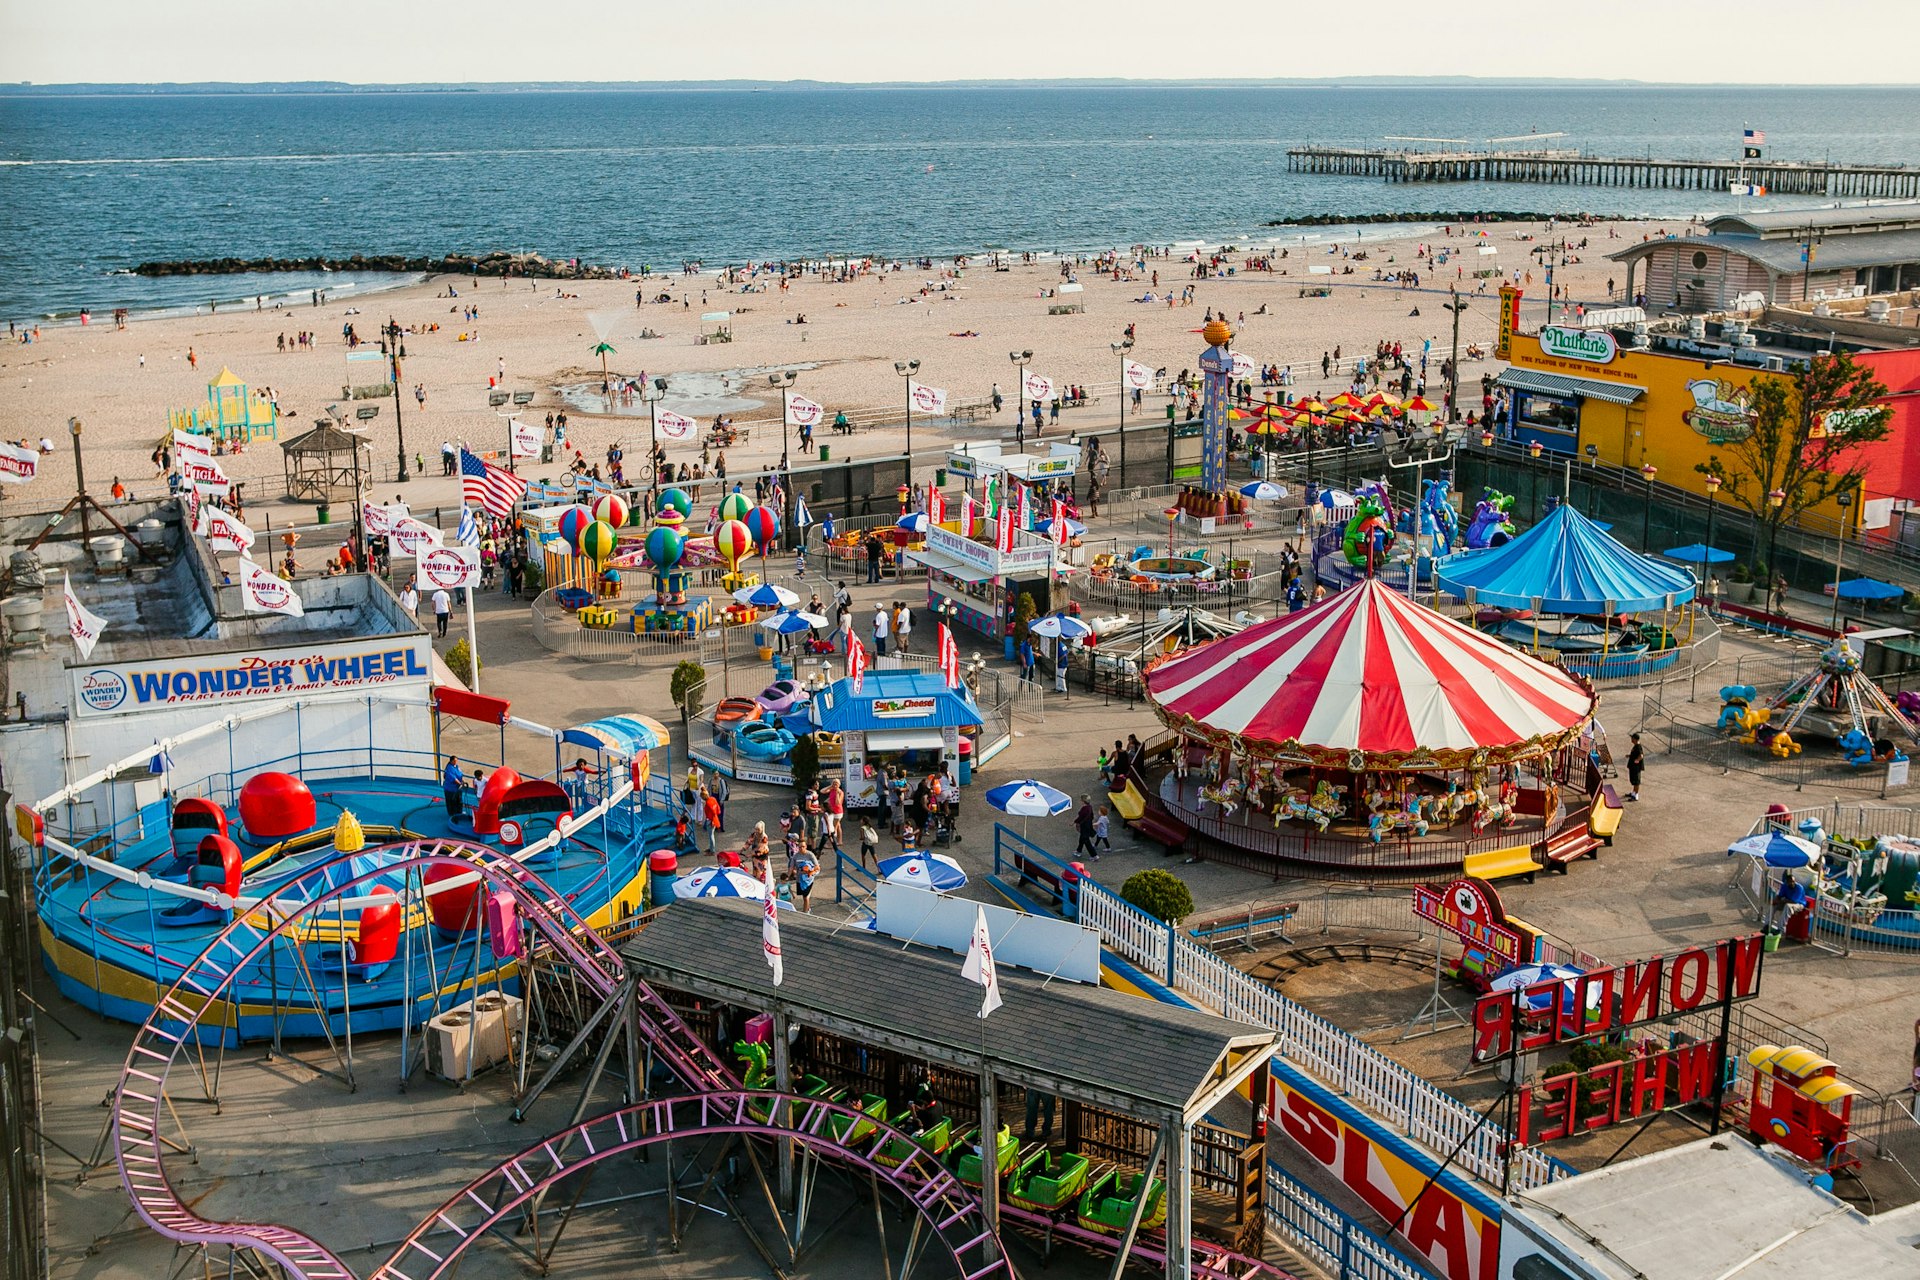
[{"left": 1473, "top": 933, "right": 1761, "bottom": 1063}]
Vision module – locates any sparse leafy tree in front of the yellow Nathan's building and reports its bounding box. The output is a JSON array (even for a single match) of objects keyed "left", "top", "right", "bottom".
[{"left": 1693, "top": 351, "right": 1891, "bottom": 556}]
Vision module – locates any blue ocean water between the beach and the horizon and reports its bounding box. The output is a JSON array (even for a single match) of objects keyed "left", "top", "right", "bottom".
[{"left": 0, "top": 86, "right": 1920, "bottom": 319}]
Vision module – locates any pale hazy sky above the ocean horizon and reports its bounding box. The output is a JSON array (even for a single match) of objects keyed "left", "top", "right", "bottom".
[{"left": 0, "top": 0, "right": 1920, "bottom": 84}]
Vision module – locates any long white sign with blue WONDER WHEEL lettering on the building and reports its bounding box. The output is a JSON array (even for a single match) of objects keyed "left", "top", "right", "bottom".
[{"left": 73, "top": 637, "right": 430, "bottom": 720}]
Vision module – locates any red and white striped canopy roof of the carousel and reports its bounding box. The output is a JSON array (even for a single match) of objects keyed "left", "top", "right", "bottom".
[{"left": 1146, "top": 580, "right": 1596, "bottom": 771}]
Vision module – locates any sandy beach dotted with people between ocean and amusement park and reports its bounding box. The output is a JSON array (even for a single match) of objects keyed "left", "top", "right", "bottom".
[{"left": 0, "top": 219, "right": 1684, "bottom": 520}]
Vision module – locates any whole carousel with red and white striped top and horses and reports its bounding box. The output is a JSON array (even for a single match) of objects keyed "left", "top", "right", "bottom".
[{"left": 1121, "top": 580, "right": 1599, "bottom": 875}]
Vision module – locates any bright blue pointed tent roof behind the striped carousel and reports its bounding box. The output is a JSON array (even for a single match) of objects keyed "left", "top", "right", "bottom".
[{"left": 1434, "top": 503, "right": 1699, "bottom": 614}]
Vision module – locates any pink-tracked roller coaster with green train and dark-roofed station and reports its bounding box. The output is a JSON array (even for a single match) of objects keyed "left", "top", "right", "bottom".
[{"left": 104, "top": 841, "right": 1284, "bottom": 1280}]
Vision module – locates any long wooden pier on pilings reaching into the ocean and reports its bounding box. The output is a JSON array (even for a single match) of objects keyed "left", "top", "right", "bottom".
[{"left": 1286, "top": 146, "right": 1920, "bottom": 200}]
